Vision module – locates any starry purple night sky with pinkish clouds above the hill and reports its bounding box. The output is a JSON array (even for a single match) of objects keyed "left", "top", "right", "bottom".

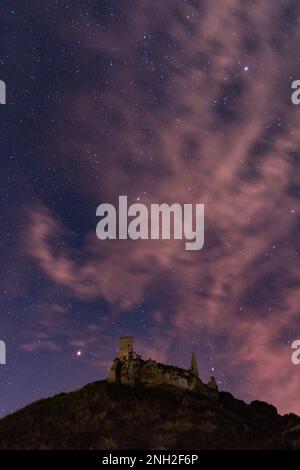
[{"left": 0, "top": 0, "right": 300, "bottom": 415}]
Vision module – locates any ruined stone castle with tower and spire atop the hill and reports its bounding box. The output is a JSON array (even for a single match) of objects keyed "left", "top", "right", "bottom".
[{"left": 108, "top": 336, "right": 219, "bottom": 398}]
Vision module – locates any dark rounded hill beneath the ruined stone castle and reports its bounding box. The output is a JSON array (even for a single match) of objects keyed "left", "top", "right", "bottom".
[{"left": 0, "top": 381, "right": 300, "bottom": 450}]
